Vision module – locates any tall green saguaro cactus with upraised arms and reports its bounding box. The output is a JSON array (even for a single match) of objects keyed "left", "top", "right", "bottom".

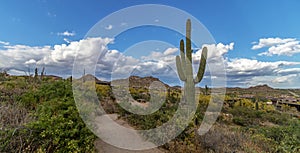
[{"left": 176, "top": 19, "right": 207, "bottom": 103}]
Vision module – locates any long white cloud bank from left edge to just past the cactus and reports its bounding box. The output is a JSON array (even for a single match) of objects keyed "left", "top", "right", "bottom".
[{"left": 0, "top": 38, "right": 233, "bottom": 82}]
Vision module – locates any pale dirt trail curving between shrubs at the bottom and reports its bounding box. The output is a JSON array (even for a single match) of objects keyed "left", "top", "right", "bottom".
[{"left": 95, "top": 114, "right": 164, "bottom": 153}]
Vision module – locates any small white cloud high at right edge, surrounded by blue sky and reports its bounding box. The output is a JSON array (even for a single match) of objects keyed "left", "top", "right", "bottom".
[{"left": 252, "top": 38, "right": 300, "bottom": 56}]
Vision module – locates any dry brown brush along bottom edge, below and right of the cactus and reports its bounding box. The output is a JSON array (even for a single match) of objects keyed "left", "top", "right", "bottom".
[{"left": 165, "top": 124, "right": 271, "bottom": 153}]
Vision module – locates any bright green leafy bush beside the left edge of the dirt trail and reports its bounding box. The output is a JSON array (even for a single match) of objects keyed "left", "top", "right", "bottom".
[{"left": 28, "top": 98, "right": 95, "bottom": 152}]
